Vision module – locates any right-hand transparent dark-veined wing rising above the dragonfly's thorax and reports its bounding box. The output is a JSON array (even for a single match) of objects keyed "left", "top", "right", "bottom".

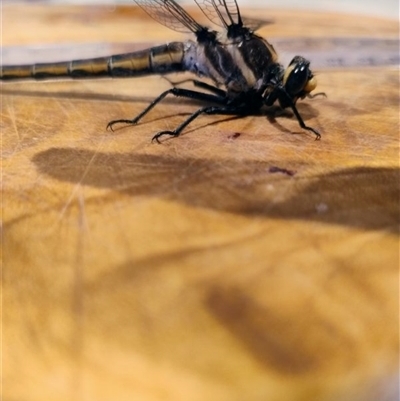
[{"left": 195, "top": 0, "right": 243, "bottom": 28}]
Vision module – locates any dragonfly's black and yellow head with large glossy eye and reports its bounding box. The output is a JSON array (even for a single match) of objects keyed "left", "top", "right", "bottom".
[{"left": 282, "top": 56, "right": 317, "bottom": 103}]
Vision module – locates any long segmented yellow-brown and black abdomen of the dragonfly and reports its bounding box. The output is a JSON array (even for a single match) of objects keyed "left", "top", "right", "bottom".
[{"left": 0, "top": 42, "right": 184, "bottom": 81}]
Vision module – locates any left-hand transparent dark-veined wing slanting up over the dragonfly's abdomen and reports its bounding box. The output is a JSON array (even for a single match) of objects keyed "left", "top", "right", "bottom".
[{"left": 133, "top": 0, "right": 204, "bottom": 33}]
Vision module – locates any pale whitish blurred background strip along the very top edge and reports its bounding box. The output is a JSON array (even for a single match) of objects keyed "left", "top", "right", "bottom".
[{"left": 2, "top": 0, "right": 399, "bottom": 19}]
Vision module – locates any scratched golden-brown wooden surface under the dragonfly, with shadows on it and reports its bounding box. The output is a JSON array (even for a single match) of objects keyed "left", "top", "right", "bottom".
[{"left": 1, "top": 6, "right": 399, "bottom": 401}]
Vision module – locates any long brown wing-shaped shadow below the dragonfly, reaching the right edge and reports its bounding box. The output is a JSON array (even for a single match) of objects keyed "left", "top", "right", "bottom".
[{"left": 33, "top": 148, "right": 400, "bottom": 232}]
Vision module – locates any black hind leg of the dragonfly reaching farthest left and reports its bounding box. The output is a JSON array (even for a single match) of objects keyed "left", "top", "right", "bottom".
[{"left": 107, "top": 88, "right": 225, "bottom": 131}]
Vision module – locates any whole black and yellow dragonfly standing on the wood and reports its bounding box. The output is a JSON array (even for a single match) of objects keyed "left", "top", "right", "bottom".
[{"left": 0, "top": 0, "right": 325, "bottom": 142}]
